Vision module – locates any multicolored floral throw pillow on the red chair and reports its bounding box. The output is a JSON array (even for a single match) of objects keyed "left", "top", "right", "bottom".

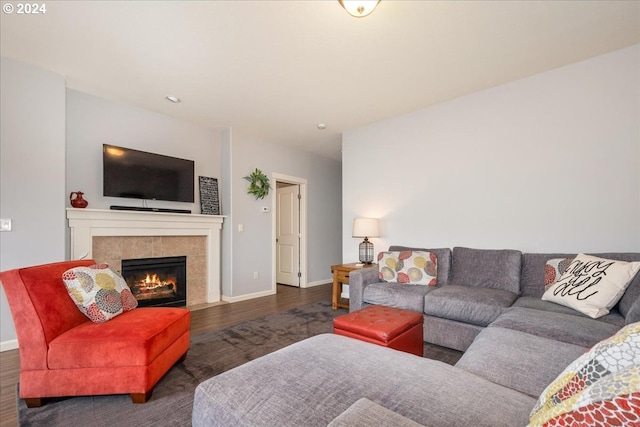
[{"left": 62, "top": 264, "right": 138, "bottom": 323}]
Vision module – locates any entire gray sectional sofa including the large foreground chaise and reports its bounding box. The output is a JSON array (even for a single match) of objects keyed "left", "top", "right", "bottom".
[{"left": 193, "top": 247, "right": 640, "bottom": 427}]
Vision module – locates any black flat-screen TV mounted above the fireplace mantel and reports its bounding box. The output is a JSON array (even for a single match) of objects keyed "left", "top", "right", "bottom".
[{"left": 102, "top": 144, "right": 194, "bottom": 203}]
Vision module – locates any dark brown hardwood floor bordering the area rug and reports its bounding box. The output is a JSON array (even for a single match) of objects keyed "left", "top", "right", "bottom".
[{"left": 0, "top": 284, "right": 462, "bottom": 427}]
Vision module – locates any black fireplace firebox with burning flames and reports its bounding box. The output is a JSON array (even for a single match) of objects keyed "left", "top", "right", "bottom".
[{"left": 122, "top": 256, "right": 187, "bottom": 307}]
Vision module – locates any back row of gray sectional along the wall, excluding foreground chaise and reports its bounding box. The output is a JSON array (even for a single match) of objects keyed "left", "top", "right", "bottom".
[{"left": 349, "top": 246, "right": 640, "bottom": 351}]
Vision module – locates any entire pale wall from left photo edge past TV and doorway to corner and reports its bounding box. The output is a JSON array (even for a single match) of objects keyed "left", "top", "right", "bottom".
[{"left": 0, "top": 71, "right": 342, "bottom": 349}]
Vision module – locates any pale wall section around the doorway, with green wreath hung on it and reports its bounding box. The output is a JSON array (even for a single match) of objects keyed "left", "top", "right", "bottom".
[{"left": 223, "top": 135, "right": 342, "bottom": 298}]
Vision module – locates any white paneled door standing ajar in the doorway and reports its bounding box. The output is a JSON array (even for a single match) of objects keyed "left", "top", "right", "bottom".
[{"left": 276, "top": 185, "right": 300, "bottom": 286}]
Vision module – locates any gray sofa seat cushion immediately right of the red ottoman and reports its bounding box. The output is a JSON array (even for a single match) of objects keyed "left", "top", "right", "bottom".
[{"left": 424, "top": 285, "right": 518, "bottom": 326}]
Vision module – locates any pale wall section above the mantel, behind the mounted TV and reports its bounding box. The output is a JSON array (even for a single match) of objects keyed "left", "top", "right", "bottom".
[{"left": 66, "top": 90, "right": 224, "bottom": 213}]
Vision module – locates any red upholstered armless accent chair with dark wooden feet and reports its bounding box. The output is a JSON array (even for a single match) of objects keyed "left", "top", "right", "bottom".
[{"left": 0, "top": 260, "right": 191, "bottom": 407}]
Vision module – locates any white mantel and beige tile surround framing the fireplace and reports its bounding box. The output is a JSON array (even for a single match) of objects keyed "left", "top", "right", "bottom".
[{"left": 67, "top": 208, "right": 224, "bottom": 307}]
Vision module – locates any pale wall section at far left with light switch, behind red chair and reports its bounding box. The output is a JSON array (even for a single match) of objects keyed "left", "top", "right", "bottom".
[{"left": 0, "top": 57, "right": 66, "bottom": 349}]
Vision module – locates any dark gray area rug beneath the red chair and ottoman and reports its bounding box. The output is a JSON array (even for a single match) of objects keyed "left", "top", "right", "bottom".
[{"left": 18, "top": 301, "right": 462, "bottom": 427}]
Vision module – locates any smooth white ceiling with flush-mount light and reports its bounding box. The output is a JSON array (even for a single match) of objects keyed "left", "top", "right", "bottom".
[{"left": 0, "top": 0, "right": 640, "bottom": 160}]
